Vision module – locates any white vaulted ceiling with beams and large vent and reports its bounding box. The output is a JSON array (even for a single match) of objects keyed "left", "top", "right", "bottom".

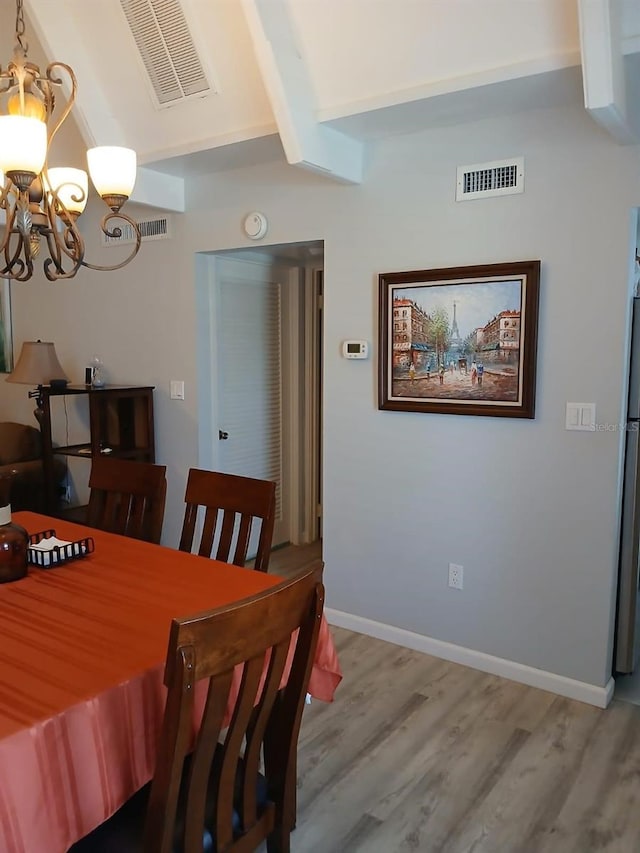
[{"left": 0, "top": 0, "right": 640, "bottom": 208}]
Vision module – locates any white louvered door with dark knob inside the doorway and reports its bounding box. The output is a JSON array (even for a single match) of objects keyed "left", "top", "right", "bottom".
[{"left": 212, "top": 257, "right": 291, "bottom": 545}]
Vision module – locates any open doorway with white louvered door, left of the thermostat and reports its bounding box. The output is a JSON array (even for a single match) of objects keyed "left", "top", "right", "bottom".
[{"left": 196, "top": 241, "right": 324, "bottom": 547}]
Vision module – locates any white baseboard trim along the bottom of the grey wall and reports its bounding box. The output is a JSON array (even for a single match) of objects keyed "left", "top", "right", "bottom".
[{"left": 325, "top": 608, "right": 615, "bottom": 708}]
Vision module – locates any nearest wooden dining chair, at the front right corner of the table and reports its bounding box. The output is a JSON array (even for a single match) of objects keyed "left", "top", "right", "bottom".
[{"left": 69, "top": 561, "right": 324, "bottom": 853}]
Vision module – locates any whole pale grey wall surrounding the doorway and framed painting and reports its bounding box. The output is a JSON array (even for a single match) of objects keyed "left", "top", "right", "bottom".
[{"left": 0, "top": 101, "right": 640, "bottom": 700}]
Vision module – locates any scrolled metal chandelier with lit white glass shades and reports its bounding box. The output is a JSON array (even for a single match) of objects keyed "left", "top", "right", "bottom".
[{"left": 0, "top": 0, "right": 141, "bottom": 281}]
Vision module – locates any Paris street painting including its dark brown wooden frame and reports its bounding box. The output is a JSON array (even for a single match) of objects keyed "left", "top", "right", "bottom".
[{"left": 378, "top": 261, "right": 540, "bottom": 418}]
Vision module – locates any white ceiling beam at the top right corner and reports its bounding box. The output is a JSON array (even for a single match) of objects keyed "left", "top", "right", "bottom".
[{"left": 578, "top": 0, "right": 640, "bottom": 145}]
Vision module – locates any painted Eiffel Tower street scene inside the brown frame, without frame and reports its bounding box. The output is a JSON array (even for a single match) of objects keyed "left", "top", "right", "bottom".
[{"left": 391, "top": 279, "right": 523, "bottom": 403}]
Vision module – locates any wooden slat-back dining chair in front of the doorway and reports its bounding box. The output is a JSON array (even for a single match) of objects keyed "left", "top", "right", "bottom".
[{"left": 179, "top": 468, "right": 276, "bottom": 572}]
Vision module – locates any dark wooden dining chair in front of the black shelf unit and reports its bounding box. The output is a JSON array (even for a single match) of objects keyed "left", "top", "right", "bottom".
[{"left": 87, "top": 456, "right": 167, "bottom": 543}]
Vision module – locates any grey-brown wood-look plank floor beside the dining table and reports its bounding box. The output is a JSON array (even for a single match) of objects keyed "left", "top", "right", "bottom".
[{"left": 270, "top": 544, "right": 640, "bottom": 853}]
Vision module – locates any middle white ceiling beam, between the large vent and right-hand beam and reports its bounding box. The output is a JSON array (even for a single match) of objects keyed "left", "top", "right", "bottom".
[{"left": 242, "top": 0, "right": 364, "bottom": 184}]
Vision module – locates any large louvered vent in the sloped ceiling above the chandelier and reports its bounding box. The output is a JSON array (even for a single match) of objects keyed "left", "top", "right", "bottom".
[{"left": 120, "top": 0, "right": 215, "bottom": 107}]
